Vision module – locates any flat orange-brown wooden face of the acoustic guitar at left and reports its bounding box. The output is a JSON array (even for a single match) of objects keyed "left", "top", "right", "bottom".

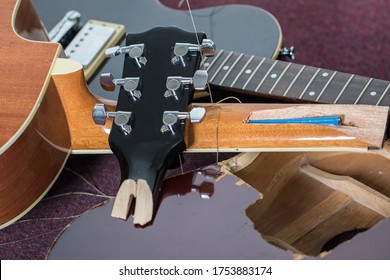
[{"left": 0, "top": 0, "right": 61, "bottom": 151}]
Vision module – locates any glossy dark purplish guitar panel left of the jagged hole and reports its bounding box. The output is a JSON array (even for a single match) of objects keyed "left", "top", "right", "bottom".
[{"left": 49, "top": 166, "right": 291, "bottom": 259}]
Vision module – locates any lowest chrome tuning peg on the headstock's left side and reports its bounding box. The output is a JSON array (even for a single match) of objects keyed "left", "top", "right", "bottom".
[{"left": 92, "top": 104, "right": 132, "bottom": 135}]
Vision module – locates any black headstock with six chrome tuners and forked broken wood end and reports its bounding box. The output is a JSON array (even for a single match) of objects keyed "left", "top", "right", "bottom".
[{"left": 93, "top": 27, "right": 214, "bottom": 224}]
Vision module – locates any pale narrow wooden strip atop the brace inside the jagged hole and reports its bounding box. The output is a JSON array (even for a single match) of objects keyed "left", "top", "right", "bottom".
[{"left": 300, "top": 165, "right": 390, "bottom": 217}]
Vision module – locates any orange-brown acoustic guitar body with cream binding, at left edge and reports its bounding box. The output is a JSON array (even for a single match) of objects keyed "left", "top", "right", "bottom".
[{"left": 0, "top": 0, "right": 70, "bottom": 228}]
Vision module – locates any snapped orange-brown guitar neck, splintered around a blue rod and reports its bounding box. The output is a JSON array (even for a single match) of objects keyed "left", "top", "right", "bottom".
[{"left": 186, "top": 104, "right": 388, "bottom": 152}]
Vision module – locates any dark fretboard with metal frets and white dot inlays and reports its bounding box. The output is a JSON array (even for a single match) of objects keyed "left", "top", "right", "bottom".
[{"left": 203, "top": 50, "right": 390, "bottom": 106}]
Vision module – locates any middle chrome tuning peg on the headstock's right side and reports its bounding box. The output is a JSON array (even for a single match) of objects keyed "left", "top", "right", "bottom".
[{"left": 164, "top": 70, "right": 208, "bottom": 100}]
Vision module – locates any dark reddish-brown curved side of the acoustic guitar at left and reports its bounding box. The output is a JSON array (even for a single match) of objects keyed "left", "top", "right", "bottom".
[{"left": 0, "top": 77, "right": 70, "bottom": 228}]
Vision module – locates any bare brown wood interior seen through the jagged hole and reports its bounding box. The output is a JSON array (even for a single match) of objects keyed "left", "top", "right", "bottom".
[{"left": 224, "top": 143, "right": 390, "bottom": 256}]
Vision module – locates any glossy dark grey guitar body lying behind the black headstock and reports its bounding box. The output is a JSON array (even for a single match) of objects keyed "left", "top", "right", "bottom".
[{"left": 33, "top": 0, "right": 282, "bottom": 103}]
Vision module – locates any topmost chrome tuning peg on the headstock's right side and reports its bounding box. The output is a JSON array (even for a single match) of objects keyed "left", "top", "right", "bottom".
[{"left": 172, "top": 39, "right": 215, "bottom": 67}]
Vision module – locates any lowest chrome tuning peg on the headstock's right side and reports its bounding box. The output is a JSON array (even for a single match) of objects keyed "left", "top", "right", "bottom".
[{"left": 161, "top": 107, "right": 206, "bottom": 134}]
